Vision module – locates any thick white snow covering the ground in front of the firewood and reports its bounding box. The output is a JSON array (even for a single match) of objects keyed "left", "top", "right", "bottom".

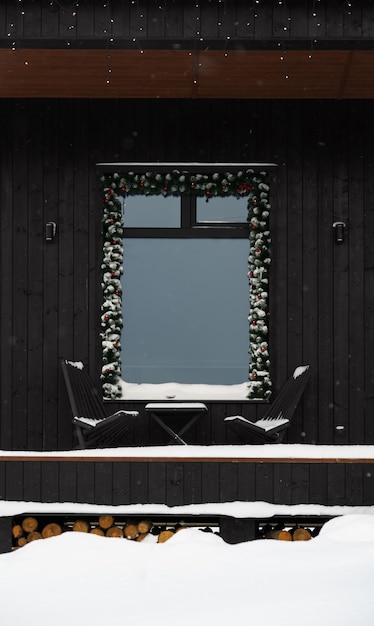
[{"left": 0, "top": 514, "right": 374, "bottom": 626}]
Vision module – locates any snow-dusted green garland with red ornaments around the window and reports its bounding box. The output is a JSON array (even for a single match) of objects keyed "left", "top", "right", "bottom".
[{"left": 101, "top": 169, "right": 271, "bottom": 399}]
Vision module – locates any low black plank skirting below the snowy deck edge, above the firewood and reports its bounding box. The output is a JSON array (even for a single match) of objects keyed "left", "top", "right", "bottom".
[{"left": 0, "top": 459, "right": 374, "bottom": 508}]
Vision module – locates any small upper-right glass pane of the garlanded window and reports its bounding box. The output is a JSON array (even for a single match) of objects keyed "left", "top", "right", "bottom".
[{"left": 196, "top": 196, "right": 248, "bottom": 223}]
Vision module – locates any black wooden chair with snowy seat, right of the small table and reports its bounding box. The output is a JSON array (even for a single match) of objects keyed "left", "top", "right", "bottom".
[{"left": 224, "top": 365, "right": 310, "bottom": 443}]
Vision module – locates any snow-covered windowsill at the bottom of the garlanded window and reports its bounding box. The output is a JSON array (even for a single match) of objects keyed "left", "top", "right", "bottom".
[{"left": 120, "top": 381, "right": 263, "bottom": 402}]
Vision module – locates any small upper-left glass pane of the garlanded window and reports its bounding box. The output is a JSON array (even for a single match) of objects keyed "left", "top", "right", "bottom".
[{"left": 120, "top": 195, "right": 181, "bottom": 228}]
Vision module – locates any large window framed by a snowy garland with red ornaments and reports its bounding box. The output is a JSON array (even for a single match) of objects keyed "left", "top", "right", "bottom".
[{"left": 102, "top": 169, "right": 270, "bottom": 399}]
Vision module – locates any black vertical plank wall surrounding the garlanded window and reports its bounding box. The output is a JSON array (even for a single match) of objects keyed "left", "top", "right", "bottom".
[{"left": 0, "top": 100, "right": 374, "bottom": 448}]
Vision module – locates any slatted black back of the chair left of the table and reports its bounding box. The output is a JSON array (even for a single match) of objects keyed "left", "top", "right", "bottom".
[{"left": 61, "top": 360, "right": 106, "bottom": 420}]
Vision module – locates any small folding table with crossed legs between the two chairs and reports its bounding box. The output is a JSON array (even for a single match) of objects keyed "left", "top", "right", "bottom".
[{"left": 145, "top": 402, "right": 208, "bottom": 446}]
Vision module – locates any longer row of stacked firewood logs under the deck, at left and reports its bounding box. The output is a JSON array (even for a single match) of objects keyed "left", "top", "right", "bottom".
[{"left": 12, "top": 515, "right": 183, "bottom": 547}]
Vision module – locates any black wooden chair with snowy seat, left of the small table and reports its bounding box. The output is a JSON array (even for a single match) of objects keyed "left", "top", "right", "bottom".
[{"left": 61, "top": 360, "right": 139, "bottom": 448}]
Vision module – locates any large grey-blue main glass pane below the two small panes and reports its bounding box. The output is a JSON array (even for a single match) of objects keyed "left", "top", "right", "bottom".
[{"left": 122, "top": 238, "right": 249, "bottom": 385}]
